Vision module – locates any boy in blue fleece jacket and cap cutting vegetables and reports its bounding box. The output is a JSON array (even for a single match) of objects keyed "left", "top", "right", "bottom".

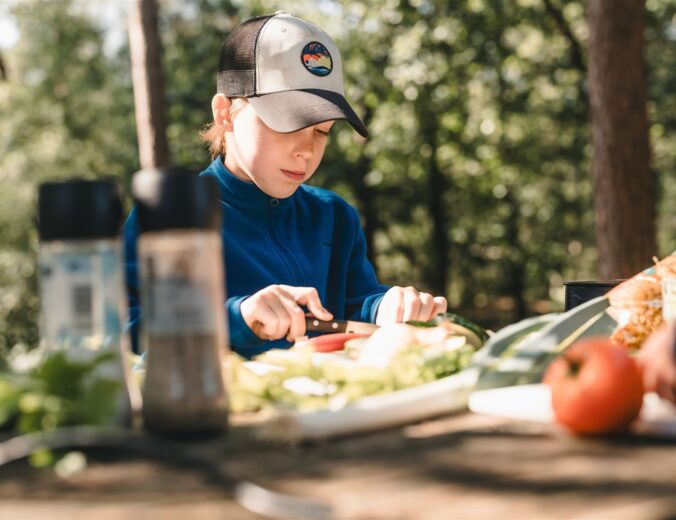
[{"left": 125, "top": 13, "right": 446, "bottom": 357}]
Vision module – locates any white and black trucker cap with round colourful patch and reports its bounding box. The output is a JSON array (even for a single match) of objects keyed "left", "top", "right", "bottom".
[{"left": 217, "top": 12, "right": 368, "bottom": 137}]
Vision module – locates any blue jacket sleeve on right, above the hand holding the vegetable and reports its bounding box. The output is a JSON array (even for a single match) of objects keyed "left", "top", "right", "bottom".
[{"left": 345, "top": 206, "right": 390, "bottom": 323}]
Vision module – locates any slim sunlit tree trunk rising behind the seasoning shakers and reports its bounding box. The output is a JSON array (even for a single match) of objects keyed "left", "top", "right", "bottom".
[{"left": 129, "top": 0, "right": 169, "bottom": 168}]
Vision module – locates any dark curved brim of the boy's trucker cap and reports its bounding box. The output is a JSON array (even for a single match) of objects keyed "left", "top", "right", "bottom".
[{"left": 248, "top": 89, "right": 369, "bottom": 137}]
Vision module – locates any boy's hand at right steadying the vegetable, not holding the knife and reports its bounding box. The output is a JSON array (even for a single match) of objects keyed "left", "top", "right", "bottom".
[{"left": 376, "top": 287, "right": 448, "bottom": 325}]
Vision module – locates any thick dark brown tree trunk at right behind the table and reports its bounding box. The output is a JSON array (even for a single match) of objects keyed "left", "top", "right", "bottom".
[{"left": 588, "top": 0, "right": 657, "bottom": 279}]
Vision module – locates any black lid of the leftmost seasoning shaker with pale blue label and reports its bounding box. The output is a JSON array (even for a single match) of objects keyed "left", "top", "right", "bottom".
[{"left": 38, "top": 179, "right": 124, "bottom": 241}]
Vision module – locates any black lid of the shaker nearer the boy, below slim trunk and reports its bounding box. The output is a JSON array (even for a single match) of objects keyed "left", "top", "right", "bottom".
[{"left": 132, "top": 168, "right": 221, "bottom": 233}]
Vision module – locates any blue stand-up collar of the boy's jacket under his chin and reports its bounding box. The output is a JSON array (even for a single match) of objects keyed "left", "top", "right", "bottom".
[{"left": 207, "top": 155, "right": 298, "bottom": 211}]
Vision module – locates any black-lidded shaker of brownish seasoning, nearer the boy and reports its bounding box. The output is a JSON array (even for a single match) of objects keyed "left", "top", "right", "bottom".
[{"left": 133, "top": 169, "right": 228, "bottom": 435}]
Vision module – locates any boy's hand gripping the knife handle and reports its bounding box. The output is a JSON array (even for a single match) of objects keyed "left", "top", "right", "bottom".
[{"left": 240, "top": 285, "right": 333, "bottom": 341}]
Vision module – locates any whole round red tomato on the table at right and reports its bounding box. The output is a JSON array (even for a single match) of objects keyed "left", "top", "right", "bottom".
[{"left": 543, "top": 337, "right": 643, "bottom": 435}]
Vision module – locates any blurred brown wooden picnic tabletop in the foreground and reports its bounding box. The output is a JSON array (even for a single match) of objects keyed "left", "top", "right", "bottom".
[{"left": 0, "top": 413, "right": 676, "bottom": 520}]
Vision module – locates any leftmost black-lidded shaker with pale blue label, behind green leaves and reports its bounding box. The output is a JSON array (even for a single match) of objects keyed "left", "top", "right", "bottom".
[{"left": 38, "top": 179, "right": 140, "bottom": 424}]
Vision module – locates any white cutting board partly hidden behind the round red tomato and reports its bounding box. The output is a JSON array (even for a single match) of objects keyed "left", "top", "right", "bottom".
[{"left": 468, "top": 384, "right": 676, "bottom": 439}]
